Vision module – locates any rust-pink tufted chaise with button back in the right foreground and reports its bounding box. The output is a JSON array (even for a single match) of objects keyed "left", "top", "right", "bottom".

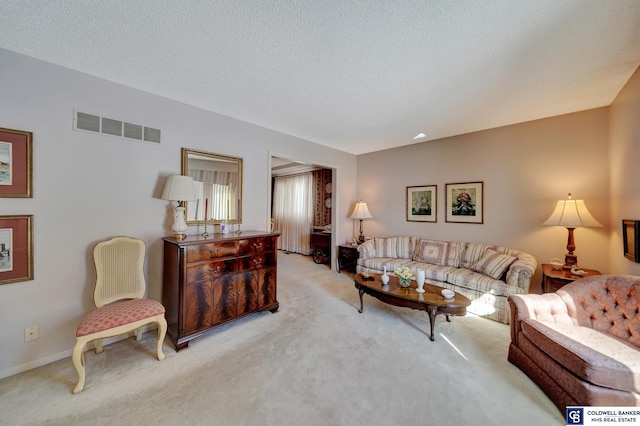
[{"left": 509, "top": 275, "right": 640, "bottom": 413}]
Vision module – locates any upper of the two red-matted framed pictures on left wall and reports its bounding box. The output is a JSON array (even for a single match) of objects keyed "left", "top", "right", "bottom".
[{"left": 0, "top": 128, "right": 33, "bottom": 198}]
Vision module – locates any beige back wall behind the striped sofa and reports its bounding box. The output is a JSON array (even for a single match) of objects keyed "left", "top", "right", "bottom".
[{"left": 358, "top": 108, "right": 609, "bottom": 291}]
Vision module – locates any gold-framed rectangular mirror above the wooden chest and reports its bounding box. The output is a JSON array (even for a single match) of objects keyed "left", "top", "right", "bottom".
[{"left": 181, "top": 148, "right": 242, "bottom": 226}]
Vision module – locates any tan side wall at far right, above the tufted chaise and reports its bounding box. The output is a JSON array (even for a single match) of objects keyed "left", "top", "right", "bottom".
[{"left": 609, "top": 68, "right": 640, "bottom": 275}]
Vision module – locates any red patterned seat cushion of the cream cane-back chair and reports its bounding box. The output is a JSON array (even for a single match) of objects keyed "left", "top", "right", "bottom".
[{"left": 76, "top": 299, "right": 165, "bottom": 337}]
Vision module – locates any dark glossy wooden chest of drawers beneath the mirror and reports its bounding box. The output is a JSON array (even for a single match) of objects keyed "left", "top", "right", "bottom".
[{"left": 162, "top": 231, "right": 280, "bottom": 350}]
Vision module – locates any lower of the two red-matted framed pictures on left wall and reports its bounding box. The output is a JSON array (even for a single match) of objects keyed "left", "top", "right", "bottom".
[{"left": 0, "top": 215, "right": 33, "bottom": 284}]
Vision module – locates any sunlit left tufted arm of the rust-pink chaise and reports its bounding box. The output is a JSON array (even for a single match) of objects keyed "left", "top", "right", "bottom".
[{"left": 507, "top": 293, "right": 578, "bottom": 344}]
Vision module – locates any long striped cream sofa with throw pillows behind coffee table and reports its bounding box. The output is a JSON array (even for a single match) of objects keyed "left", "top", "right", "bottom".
[{"left": 356, "top": 236, "right": 537, "bottom": 324}]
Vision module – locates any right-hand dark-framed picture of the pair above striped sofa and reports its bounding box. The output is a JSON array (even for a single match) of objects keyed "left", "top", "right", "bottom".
[{"left": 445, "top": 182, "right": 484, "bottom": 223}]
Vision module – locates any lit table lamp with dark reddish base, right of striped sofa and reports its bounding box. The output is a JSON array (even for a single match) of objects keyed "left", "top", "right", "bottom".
[{"left": 543, "top": 193, "right": 602, "bottom": 268}]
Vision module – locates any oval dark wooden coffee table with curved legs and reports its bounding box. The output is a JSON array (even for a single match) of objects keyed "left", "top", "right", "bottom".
[{"left": 353, "top": 274, "right": 471, "bottom": 341}]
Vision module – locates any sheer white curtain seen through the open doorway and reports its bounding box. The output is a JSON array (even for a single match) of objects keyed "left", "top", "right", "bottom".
[{"left": 273, "top": 173, "right": 313, "bottom": 255}]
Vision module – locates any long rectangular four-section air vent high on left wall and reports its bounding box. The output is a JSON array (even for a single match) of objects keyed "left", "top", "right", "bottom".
[{"left": 73, "top": 110, "right": 162, "bottom": 143}]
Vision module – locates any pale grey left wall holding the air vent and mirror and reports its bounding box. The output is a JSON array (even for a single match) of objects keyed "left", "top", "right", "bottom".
[{"left": 0, "top": 49, "right": 356, "bottom": 377}]
